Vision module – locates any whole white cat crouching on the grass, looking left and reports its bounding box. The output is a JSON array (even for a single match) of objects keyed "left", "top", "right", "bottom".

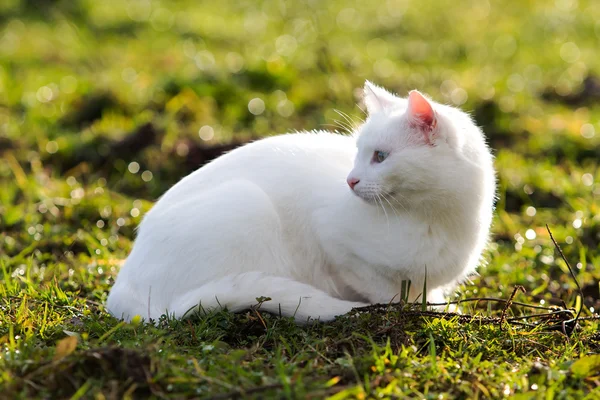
[{"left": 107, "top": 82, "right": 495, "bottom": 323}]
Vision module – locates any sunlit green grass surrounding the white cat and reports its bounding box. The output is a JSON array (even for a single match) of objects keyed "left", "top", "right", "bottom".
[{"left": 0, "top": 0, "right": 600, "bottom": 399}]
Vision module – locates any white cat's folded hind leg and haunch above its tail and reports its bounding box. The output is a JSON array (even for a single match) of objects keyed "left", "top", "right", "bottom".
[{"left": 107, "top": 180, "right": 289, "bottom": 320}]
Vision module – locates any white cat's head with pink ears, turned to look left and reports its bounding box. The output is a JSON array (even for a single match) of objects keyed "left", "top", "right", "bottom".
[{"left": 347, "top": 82, "right": 494, "bottom": 214}]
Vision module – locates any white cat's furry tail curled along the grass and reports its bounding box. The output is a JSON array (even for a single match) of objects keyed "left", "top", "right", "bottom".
[{"left": 168, "top": 272, "right": 366, "bottom": 324}]
